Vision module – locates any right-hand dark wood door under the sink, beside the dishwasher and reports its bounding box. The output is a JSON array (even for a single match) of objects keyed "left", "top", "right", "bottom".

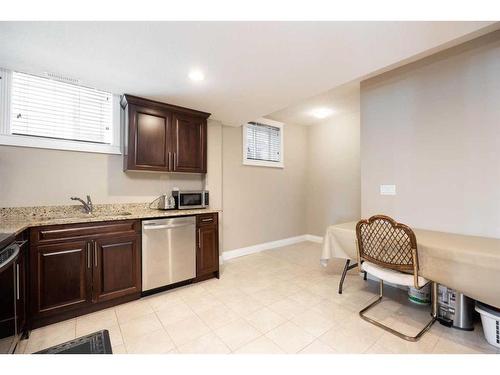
[{"left": 93, "top": 235, "right": 141, "bottom": 302}]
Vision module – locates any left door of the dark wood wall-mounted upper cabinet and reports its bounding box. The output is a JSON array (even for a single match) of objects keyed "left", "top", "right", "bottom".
[{"left": 126, "top": 105, "right": 171, "bottom": 171}]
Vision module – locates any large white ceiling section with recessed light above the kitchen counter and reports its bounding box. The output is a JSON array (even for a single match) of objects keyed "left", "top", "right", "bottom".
[{"left": 0, "top": 22, "right": 496, "bottom": 126}]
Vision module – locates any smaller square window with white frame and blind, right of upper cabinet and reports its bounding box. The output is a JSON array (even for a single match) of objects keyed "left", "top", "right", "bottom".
[{"left": 243, "top": 119, "right": 284, "bottom": 168}]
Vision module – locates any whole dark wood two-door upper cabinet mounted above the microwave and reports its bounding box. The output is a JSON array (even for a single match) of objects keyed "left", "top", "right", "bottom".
[{"left": 121, "top": 95, "right": 210, "bottom": 173}]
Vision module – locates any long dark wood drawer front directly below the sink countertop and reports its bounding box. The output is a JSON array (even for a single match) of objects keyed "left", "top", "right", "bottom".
[{"left": 31, "top": 220, "right": 140, "bottom": 244}]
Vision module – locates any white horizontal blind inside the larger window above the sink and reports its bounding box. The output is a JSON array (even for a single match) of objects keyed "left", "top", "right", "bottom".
[{"left": 10, "top": 72, "right": 113, "bottom": 144}]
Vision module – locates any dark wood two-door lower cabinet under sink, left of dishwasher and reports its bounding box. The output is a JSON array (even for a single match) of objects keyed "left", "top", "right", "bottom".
[{"left": 29, "top": 220, "right": 141, "bottom": 328}]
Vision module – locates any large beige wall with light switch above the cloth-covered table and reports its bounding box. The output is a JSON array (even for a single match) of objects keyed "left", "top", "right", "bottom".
[{"left": 361, "top": 32, "right": 500, "bottom": 237}]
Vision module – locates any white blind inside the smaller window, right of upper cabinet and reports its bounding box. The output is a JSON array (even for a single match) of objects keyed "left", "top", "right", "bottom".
[{"left": 246, "top": 122, "right": 282, "bottom": 163}]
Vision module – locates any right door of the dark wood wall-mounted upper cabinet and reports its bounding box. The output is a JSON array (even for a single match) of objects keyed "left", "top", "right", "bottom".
[{"left": 172, "top": 114, "right": 207, "bottom": 173}]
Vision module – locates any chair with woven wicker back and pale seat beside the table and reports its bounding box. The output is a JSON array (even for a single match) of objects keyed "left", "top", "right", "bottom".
[{"left": 356, "top": 215, "right": 437, "bottom": 341}]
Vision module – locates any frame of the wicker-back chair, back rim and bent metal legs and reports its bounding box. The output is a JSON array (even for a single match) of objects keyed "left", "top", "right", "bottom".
[{"left": 356, "top": 215, "right": 438, "bottom": 342}]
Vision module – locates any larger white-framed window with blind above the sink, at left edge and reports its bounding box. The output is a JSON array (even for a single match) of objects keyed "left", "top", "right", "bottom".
[{"left": 0, "top": 69, "right": 120, "bottom": 154}]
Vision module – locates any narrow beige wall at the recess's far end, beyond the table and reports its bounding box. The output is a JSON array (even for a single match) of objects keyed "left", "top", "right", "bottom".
[{"left": 306, "top": 113, "right": 361, "bottom": 236}]
